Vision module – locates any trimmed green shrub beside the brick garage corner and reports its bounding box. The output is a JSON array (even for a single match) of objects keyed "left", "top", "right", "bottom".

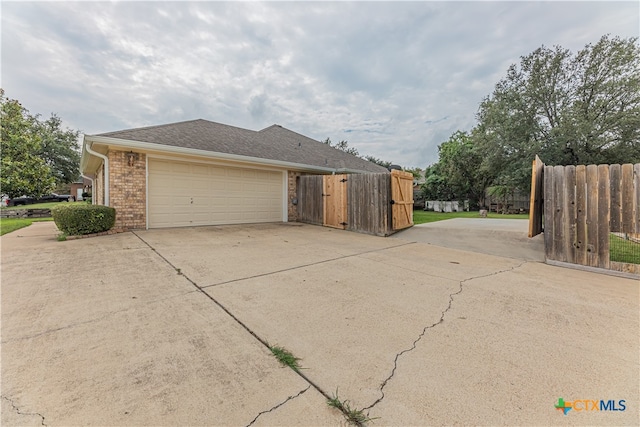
[{"left": 51, "top": 203, "right": 116, "bottom": 236}]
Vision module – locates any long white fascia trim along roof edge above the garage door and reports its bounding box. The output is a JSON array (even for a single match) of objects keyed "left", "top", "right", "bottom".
[{"left": 85, "top": 135, "right": 371, "bottom": 173}]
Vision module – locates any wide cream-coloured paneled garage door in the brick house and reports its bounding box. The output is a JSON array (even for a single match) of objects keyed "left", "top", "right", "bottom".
[{"left": 148, "top": 159, "right": 284, "bottom": 228}]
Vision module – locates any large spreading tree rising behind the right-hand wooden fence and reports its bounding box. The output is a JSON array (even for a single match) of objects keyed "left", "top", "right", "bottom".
[{"left": 472, "top": 36, "right": 640, "bottom": 190}]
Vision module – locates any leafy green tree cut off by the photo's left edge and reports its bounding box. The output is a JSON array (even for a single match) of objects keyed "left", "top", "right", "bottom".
[{"left": 0, "top": 89, "right": 55, "bottom": 197}]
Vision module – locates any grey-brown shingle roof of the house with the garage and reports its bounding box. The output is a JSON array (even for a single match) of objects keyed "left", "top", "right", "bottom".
[{"left": 87, "top": 119, "right": 388, "bottom": 173}]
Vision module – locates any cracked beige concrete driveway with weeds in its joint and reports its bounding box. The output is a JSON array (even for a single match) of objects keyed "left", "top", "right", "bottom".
[{"left": 1, "top": 223, "right": 640, "bottom": 425}]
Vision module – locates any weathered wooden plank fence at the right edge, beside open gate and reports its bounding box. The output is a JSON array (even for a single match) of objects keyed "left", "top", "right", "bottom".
[{"left": 530, "top": 159, "right": 640, "bottom": 274}]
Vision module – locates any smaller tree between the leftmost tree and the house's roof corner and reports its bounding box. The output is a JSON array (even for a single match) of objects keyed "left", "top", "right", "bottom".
[{"left": 37, "top": 114, "right": 80, "bottom": 185}]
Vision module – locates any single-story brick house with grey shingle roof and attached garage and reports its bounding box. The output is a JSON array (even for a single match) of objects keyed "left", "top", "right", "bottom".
[{"left": 80, "top": 119, "right": 388, "bottom": 229}]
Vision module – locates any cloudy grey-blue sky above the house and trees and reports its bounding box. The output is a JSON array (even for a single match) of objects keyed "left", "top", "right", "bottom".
[{"left": 1, "top": 0, "right": 640, "bottom": 167}]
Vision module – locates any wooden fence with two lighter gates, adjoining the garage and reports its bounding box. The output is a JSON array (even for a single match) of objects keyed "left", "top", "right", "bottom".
[{"left": 297, "top": 170, "right": 413, "bottom": 236}]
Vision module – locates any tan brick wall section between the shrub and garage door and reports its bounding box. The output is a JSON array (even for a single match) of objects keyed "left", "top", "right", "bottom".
[{"left": 108, "top": 151, "right": 147, "bottom": 229}]
